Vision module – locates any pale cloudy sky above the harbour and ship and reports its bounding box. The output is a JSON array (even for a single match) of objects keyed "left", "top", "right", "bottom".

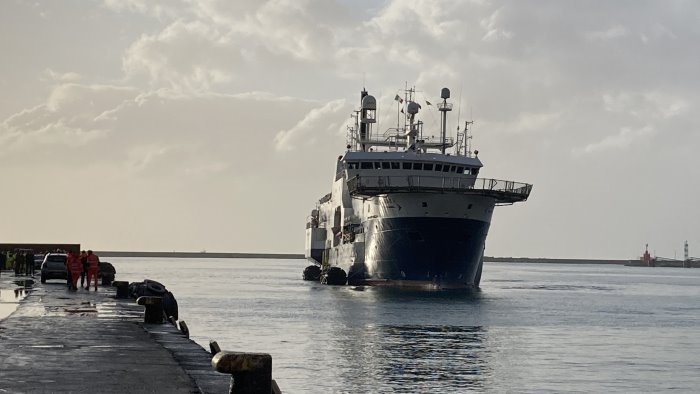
[{"left": 0, "top": 0, "right": 700, "bottom": 259}]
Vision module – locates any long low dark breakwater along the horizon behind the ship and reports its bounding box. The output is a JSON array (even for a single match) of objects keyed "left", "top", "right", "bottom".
[{"left": 96, "top": 250, "right": 630, "bottom": 265}]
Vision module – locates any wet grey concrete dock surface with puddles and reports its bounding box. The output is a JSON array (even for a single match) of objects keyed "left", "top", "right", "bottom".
[{"left": 0, "top": 271, "right": 231, "bottom": 393}]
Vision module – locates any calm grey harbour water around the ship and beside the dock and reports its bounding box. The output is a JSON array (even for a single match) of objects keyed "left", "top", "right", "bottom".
[{"left": 110, "top": 258, "right": 700, "bottom": 393}]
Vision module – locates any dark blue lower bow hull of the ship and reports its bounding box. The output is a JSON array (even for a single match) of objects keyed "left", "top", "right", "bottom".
[{"left": 364, "top": 217, "right": 489, "bottom": 287}]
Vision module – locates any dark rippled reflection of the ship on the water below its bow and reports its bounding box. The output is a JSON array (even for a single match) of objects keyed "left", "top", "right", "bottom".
[{"left": 329, "top": 288, "right": 491, "bottom": 392}]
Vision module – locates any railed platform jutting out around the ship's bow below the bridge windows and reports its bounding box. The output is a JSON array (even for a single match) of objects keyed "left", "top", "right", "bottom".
[{"left": 347, "top": 175, "right": 532, "bottom": 204}]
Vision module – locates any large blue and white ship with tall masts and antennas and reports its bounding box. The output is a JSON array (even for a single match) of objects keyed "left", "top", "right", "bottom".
[{"left": 303, "top": 87, "right": 532, "bottom": 289}]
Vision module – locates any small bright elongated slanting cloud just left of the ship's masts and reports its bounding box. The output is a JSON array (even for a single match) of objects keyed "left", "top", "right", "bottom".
[{"left": 274, "top": 100, "right": 349, "bottom": 151}]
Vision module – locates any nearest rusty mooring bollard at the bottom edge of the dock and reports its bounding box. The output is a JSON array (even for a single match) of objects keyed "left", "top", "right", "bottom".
[{"left": 211, "top": 351, "right": 277, "bottom": 394}]
